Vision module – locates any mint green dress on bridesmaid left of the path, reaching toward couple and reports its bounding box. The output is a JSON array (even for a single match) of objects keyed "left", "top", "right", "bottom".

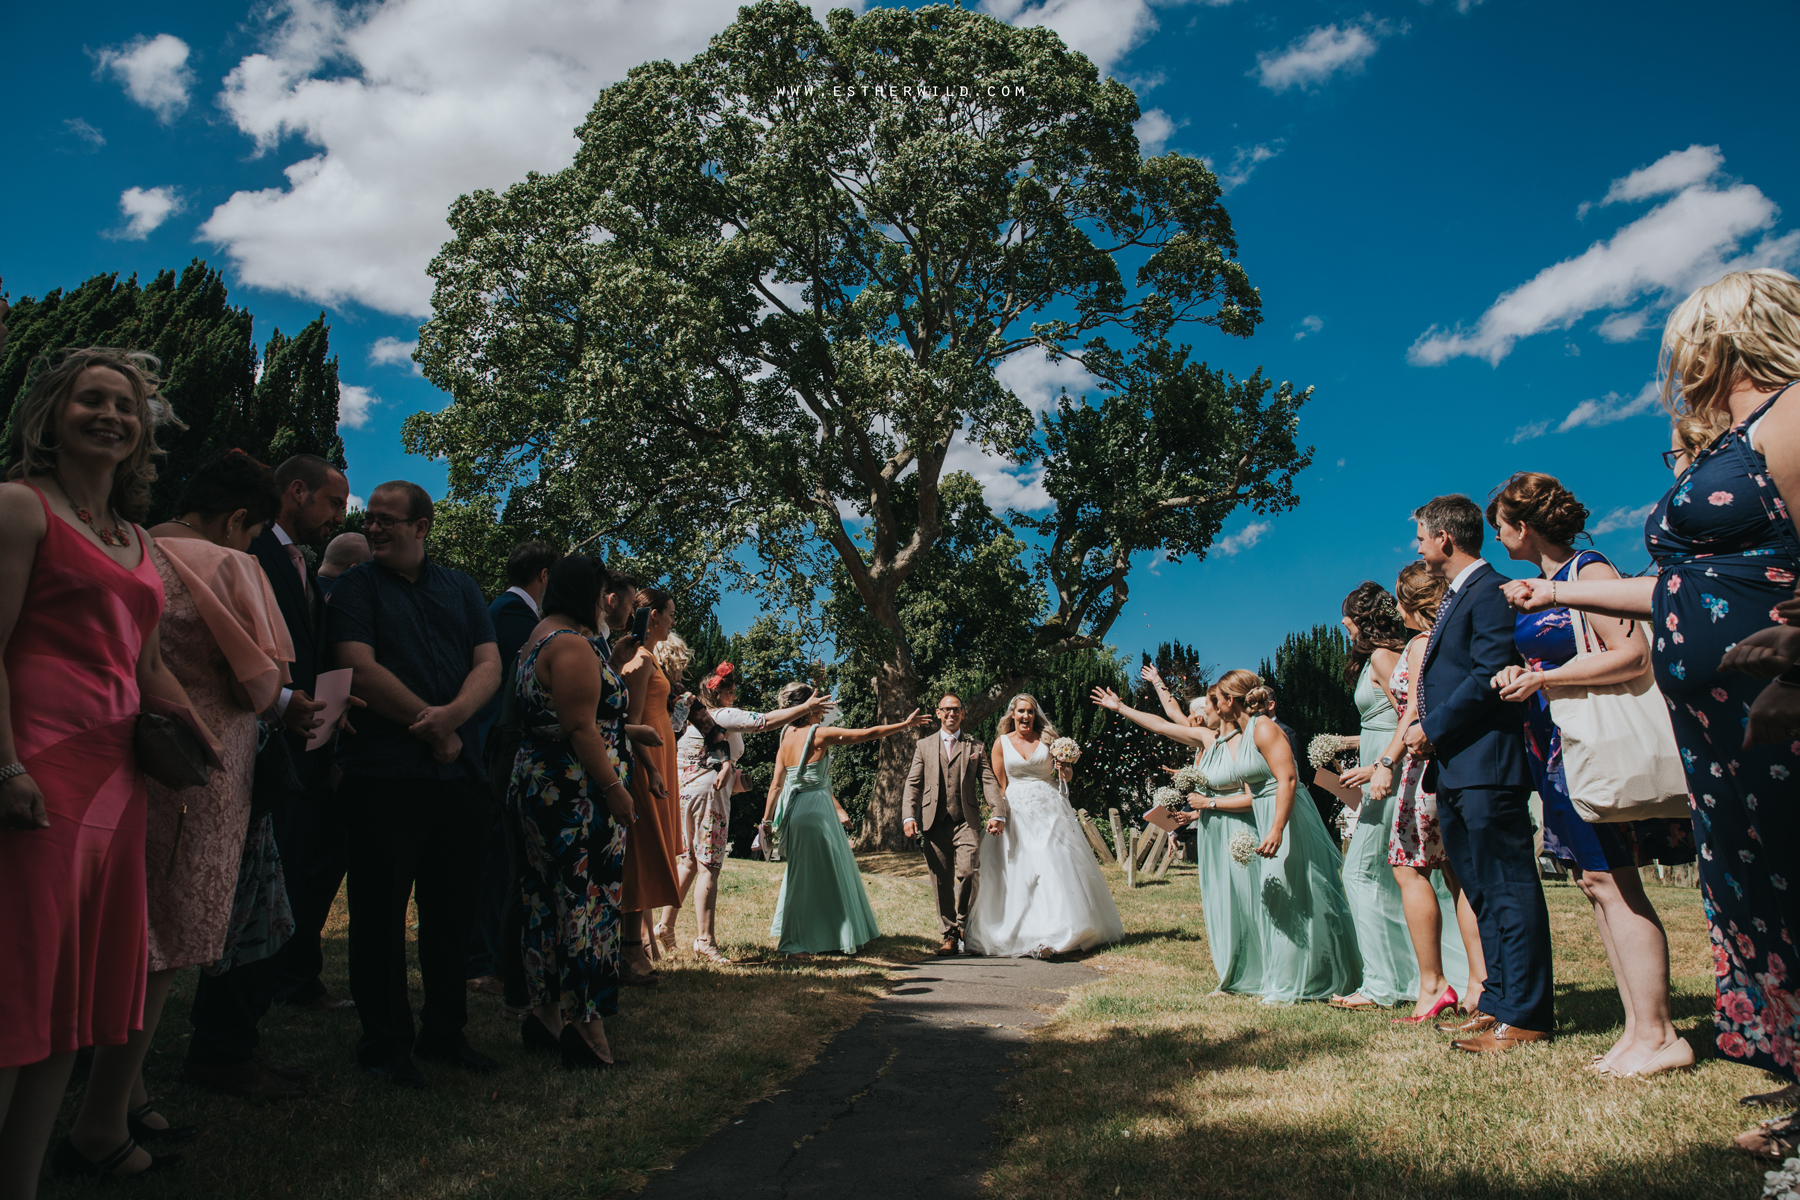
[{"left": 769, "top": 725, "right": 880, "bottom": 954}]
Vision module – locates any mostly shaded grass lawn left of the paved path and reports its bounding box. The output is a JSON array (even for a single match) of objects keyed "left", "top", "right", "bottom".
[{"left": 40, "top": 856, "right": 938, "bottom": 1200}]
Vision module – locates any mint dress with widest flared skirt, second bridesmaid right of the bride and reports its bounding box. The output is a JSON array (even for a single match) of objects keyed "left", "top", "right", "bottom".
[{"left": 1206, "top": 716, "right": 1363, "bottom": 1004}]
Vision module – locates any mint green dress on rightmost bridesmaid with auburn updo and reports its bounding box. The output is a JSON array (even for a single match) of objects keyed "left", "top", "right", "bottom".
[{"left": 1343, "top": 660, "right": 1418, "bottom": 1006}]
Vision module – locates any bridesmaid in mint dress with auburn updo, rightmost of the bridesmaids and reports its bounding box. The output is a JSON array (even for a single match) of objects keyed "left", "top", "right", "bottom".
[{"left": 1332, "top": 581, "right": 1420, "bottom": 1009}]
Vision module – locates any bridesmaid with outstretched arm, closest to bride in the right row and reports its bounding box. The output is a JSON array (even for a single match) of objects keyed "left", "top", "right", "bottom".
[{"left": 1102, "top": 666, "right": 1262, "bottom": 995}]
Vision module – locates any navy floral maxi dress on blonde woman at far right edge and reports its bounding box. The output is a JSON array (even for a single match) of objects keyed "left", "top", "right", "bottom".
[{"left": 1643, "top": 386, "right": 1800, "bottom": 1079}]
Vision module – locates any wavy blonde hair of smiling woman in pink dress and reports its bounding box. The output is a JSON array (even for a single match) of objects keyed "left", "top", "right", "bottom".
[{"left": 5, "top": 345, "right": 176, "bottom": 522}]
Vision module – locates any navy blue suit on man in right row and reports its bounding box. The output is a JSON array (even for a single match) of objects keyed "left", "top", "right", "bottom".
[{"left": 1420, "top": 563, "right": 1555, "bottom": 1033}]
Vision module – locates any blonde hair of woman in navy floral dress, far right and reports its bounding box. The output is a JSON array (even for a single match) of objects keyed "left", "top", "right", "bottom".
[{"left": 1658, "top": 266, "right": 1800, "bottom": 417}]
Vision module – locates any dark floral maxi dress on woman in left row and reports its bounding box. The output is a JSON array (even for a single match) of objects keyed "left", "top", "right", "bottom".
[{"left": 506, "top": 630, "right": 630, "bottom": 1022}]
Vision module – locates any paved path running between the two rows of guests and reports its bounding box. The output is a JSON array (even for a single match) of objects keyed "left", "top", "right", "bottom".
[{"left": 643, "top": 957, "right": 1096, "bottom": 1200}]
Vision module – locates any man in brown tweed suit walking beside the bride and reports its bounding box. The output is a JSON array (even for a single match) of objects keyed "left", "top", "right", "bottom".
[{"left": 900, "top": 693, "right": 1006, "bottom": 954}]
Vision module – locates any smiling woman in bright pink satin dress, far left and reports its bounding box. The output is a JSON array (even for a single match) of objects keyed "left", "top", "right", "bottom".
[{"left": 0, "top": 349, "right": 220, "bottom": 1200}]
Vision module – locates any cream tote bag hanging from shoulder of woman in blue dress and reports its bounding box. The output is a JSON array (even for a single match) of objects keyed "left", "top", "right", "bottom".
[{"left": 1544, "top": 608, "right": 1694, "bottom": 824}]
